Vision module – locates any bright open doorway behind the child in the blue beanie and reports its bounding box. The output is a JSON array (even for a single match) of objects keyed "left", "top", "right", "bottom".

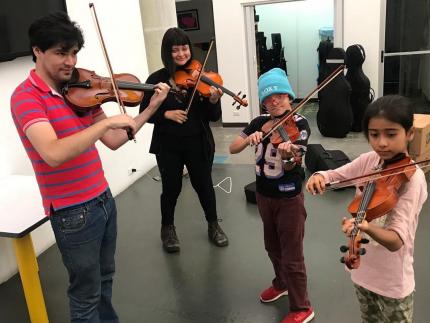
[{"left": 245, "top": 0, "right": 335, "bottom": 117}]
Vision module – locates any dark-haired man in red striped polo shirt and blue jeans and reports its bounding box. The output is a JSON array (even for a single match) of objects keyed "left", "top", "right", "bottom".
[{"left": 11, "top": 13, "right": 169, "bottom": 322}]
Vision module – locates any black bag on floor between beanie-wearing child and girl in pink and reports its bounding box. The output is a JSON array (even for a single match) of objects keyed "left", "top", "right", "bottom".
[{"left": 305, "top": 144, "right": 351, "bottom": 173}]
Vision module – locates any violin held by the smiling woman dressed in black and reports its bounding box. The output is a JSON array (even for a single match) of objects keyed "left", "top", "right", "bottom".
[{"left": 174, "top": 59, "right": 248, "bottom": 109}]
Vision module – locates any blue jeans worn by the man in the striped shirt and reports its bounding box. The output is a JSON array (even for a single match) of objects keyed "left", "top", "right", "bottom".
[{"left": 50, "top": 189, "right": 119, "bottom": 323}]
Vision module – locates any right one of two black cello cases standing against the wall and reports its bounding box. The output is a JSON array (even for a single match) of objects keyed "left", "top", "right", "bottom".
[{"left": 345, "top": 44, "right": 374, "bottom": 132}]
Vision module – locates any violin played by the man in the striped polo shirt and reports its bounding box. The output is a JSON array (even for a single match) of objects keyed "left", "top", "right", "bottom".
[{"left": 62, "top": 68, "right": 182, "bottom": 112}]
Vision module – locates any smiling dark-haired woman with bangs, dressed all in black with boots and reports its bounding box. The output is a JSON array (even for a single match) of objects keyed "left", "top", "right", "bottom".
[{"left": 140, "top": 28, "right": 228, "bottom": 253}]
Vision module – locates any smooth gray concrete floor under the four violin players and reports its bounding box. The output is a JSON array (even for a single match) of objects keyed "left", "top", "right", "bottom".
[{"left": 0, "top": 105, "right": 430, "bottom": 323}]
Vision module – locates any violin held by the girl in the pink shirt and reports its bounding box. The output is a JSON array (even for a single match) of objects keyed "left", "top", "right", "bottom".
[{"left": 340, "top": 153, "right": 416, "bottom": 269}]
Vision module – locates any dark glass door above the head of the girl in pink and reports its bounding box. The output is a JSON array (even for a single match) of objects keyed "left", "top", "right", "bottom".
[{"left": 381, "top": 0, "right": 430, "bottom": 113}]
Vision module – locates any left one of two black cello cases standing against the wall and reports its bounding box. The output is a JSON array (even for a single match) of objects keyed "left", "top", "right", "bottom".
[{"left": 317, "top": 47, "right": 352, "bottom": 138}]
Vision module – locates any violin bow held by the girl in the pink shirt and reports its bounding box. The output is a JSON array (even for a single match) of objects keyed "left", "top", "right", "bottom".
[{"left": 326, "top": 158, "right": 430, "bottom": 190}]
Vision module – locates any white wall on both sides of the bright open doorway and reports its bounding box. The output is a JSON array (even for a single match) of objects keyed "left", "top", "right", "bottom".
[{"left": 213, "top": 0, "right": 384, "bottom": 123}]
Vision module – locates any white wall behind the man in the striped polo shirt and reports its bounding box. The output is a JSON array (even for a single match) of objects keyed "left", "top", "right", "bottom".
[{"left": 0, "top": 0, "right": 155, "bottom": 282}]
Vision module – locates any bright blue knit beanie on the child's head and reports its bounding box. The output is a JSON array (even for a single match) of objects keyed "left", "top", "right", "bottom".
[{"left": 258, "top": 67, "right": 296, "bottom": 103}]
